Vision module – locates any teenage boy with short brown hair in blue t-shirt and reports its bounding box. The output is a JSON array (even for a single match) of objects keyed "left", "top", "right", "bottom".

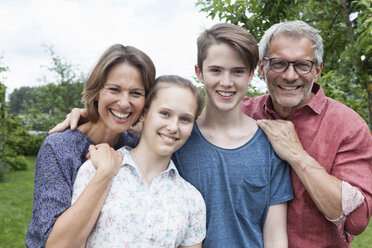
[{"left": 47, "top": 23, "right": 293, "bottom": 248}]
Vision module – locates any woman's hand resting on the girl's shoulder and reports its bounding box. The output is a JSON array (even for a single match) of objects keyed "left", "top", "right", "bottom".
[{"left": 87, "top": 143, "right": 123, "bottom": 178}]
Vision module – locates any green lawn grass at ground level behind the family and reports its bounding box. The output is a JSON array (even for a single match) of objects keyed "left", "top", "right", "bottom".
[{"left": 0, "top": 157, "right": 372, "bottom": 248}]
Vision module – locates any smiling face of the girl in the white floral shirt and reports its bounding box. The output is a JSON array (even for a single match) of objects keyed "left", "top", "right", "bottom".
[{"left": 141, "top": 85, "right": 197, "bottom": 156}]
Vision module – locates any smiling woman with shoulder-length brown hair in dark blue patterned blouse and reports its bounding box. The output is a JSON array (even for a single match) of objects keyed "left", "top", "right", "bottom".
[{"left": 26, "top": 44, "right": 155, "bottom": 247}]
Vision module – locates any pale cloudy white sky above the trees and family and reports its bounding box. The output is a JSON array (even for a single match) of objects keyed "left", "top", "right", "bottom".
[{"left": 0, "top": 0, "right": 230, "bottom": 98}]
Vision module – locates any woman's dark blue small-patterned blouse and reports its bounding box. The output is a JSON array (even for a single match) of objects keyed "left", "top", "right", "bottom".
[{"left": 26, "top": 129, "right": 138, "bottom": 248}]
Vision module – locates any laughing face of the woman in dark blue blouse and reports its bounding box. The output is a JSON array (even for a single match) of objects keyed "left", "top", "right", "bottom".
[{"left": 98, "top": 62, "right": 145, "bottom": 134}]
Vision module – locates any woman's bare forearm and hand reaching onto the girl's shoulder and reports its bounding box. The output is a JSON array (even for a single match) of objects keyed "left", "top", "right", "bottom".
[{"left": 46, "top": 144, "right": 122, "bottom": 247}]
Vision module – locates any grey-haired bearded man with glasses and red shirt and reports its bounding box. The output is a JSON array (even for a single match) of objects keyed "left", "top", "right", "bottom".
[{"left": 242, "top": 21, "right": 372, "bottom": 248}]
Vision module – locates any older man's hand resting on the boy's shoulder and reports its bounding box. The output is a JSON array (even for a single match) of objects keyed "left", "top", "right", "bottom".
[{"left": 257, "top": 120, "right": 306, "bottom": 163}]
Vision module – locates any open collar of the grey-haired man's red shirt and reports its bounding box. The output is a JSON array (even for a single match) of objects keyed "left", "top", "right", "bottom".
[{"left": 263, "top": 83, "right": 326, "bottom": 114}]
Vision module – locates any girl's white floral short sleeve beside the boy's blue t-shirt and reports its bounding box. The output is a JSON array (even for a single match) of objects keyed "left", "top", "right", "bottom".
[{"left": 181, "top": 189, "right": 207, "bottom": 246}]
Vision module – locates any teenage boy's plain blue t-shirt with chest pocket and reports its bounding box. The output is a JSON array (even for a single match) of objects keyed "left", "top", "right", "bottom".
[{"left": 173, "top": 124, "right": 293, "bottom": 248}]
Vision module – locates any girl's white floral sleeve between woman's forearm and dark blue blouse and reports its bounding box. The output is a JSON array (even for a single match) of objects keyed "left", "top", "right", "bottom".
[{"left": 71, "top": 160, "right": 96, "bottom": 205}]
